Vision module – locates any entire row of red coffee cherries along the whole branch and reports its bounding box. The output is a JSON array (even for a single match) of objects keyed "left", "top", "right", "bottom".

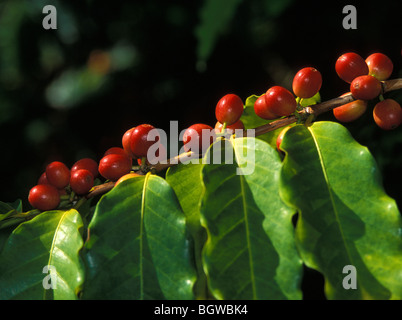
[{"left": 28, "top": 53, "right": 402, "bottom": 210}]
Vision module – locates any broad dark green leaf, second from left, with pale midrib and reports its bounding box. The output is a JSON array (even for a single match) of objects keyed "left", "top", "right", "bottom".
[{"left": 83, "top": 175, "right": 195, "bottom": 300}]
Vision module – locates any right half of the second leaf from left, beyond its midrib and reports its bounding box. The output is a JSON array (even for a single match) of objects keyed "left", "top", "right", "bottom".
[{"left": 143, "top": 175, "right": 196, "bottom": 299}]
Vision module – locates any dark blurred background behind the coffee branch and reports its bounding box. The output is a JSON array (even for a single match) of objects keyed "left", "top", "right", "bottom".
[{"left": 0, "top": 0, "right": 402, "bottom": 298}]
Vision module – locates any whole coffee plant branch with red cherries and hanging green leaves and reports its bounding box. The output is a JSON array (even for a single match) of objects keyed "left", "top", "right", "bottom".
[{"left": 0, "top": 53, "right": 402, "bottom": 300}]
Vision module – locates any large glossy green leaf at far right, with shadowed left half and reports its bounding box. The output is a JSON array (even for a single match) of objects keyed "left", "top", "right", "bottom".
[{"left": 281, "top": 122, "right": 402, "bottom": 299}]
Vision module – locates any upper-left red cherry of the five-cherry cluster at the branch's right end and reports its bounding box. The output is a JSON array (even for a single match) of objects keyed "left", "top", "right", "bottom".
[{"left": 335, "top": 52, "right": 369, "bottom": 83}]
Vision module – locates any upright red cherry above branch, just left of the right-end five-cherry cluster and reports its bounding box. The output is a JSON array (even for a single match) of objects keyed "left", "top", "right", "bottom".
[{"left": 292, "top": 67, "right": 322, "bottom": 99}]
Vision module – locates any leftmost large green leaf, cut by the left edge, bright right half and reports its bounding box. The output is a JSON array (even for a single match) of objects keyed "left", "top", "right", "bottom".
[{"left": 0, "top": 210, "right": 84, "bottom": 300}]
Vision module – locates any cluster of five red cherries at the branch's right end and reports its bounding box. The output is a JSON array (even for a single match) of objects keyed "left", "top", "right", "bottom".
[{"left": 333, "top": 52, "right": 402, "bottom": 130}]
